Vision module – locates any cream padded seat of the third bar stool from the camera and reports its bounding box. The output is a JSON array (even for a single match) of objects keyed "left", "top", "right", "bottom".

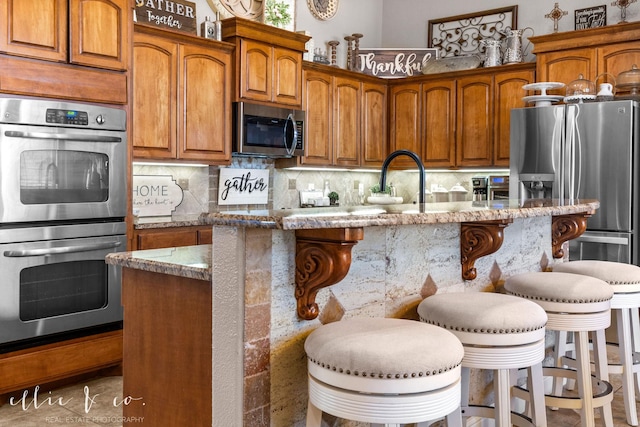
[{"left": 504, "top": 272, "right": 613, "bottom": 313}]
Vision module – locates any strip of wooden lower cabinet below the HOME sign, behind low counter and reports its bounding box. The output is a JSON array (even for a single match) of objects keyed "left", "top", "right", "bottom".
[{"left": 132, "top": 226, "right": 213, "bottom": 250}]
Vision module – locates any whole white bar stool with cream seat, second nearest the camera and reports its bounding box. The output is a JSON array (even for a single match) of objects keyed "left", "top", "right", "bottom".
[{"left": 418, "top": 292, "right": 547, "bottom": 427}]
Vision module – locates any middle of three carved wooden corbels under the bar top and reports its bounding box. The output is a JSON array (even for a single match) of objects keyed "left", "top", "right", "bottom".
[{"left": 460, "top": 219, "right": 513, "bottom": 280}]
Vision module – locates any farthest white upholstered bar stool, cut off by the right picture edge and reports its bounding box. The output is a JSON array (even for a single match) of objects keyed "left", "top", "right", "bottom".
[{"left": 553, "top": 261, "right": 640, "bottom": 426}]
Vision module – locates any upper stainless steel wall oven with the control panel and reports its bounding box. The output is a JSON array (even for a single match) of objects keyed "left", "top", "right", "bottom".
[{"left": 0, "top": 98, "right": 127, "bottom": 223}]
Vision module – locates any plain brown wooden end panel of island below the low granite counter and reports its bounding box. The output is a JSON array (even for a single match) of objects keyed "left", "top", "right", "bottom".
[{"left": 122, "top": 268, "right": 210, "bottom": 427}]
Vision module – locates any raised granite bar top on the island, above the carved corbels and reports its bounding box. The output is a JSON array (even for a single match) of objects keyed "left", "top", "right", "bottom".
[{"left": 200, "top": 199, "right": 600, "bottom": 230}]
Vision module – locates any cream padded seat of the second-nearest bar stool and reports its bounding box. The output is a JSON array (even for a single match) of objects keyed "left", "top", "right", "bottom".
[{"left": 418, "top": 292, "right": 547, "bottom": 345}]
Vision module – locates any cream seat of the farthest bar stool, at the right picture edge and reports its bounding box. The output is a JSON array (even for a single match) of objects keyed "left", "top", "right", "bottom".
[{"left": 553, "top": 260, "right": 640, "bottom": 293}]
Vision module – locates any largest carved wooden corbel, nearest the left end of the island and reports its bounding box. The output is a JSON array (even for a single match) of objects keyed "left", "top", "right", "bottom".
[{"left": 295, "top": 228, "right": 364, "bottom": 320}]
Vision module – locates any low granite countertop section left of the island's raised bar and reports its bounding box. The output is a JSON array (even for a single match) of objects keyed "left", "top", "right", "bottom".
[{"left": 105, "top": 245, "right": 211, "bottom": 282}]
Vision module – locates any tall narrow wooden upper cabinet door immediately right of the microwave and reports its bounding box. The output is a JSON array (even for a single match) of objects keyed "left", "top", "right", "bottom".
[{"left": 301, "top": 70, "right": 333, "bottom": 165}]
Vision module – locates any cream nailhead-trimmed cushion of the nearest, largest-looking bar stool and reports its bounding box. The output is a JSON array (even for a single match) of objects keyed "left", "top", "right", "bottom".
[{"left": 304, "top": 318, "right": 464, "bottom": 380}]
